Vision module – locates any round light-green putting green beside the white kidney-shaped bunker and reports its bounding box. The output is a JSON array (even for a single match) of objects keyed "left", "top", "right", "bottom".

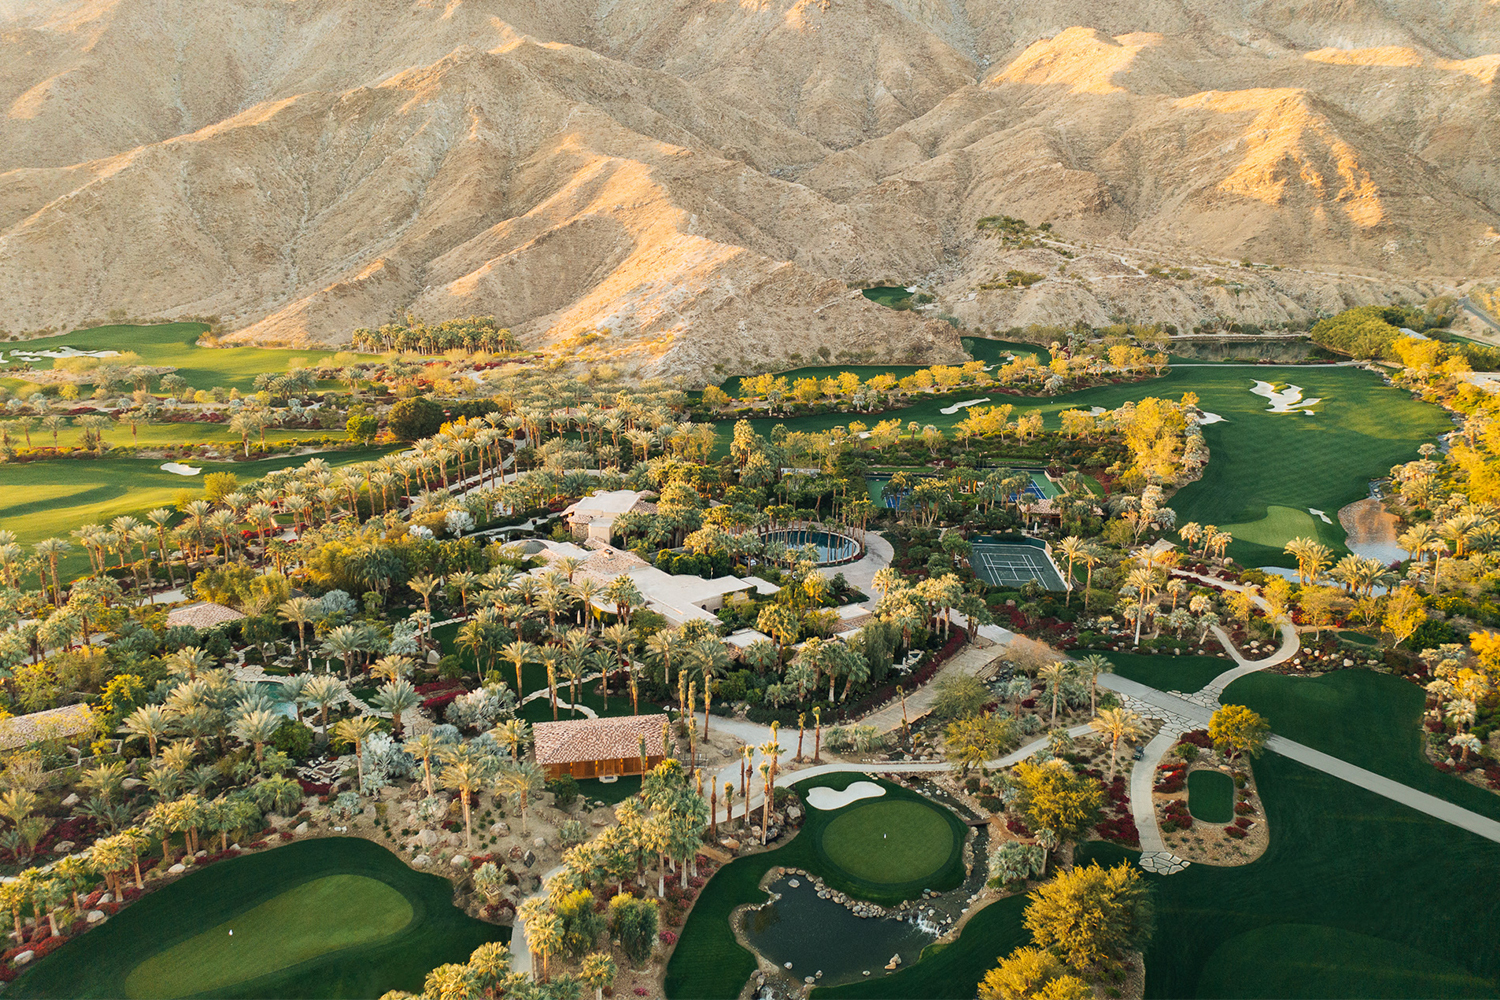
[{"left": 822, "top": 799, "right": 953, "bottom": 885}]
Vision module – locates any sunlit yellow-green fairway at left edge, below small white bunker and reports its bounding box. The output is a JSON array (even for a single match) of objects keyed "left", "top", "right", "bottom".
[{"left": 0, "top": 448, "right": 405, "bottom": 576}]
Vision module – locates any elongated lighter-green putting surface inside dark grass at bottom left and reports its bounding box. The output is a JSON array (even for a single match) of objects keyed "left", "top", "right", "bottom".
[{"left": 125, "top": 876, "right": 413, "bottom": 1000}]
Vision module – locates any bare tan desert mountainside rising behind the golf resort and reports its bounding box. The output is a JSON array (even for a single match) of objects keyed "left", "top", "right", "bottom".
[{"left": 0, "top": 0, "right": 1500, "bottom": 378}]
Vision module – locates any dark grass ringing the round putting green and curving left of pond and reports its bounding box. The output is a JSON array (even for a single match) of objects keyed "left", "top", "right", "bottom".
[{"left": 666, "top": 774, "right": 972, "bottom": 1000}]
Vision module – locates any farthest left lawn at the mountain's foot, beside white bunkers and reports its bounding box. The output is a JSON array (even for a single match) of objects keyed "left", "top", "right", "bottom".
[{"left": 0, "top": 322, "right": 343, "bottom": 393}]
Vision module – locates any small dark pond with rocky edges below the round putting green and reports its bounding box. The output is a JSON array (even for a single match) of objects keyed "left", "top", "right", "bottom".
[{"left": 740, "top": 876, "right": 938, "bottom": 987}]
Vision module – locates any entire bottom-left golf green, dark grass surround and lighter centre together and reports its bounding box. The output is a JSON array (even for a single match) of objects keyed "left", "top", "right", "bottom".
[{"left": 6, "top": 838, "right": 510, "bottom": 999}]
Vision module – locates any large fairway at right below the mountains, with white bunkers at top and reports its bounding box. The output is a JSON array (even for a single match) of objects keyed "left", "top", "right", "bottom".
[{"left": 720, "top": 364, "right": 1452, "bottom": 567}]
